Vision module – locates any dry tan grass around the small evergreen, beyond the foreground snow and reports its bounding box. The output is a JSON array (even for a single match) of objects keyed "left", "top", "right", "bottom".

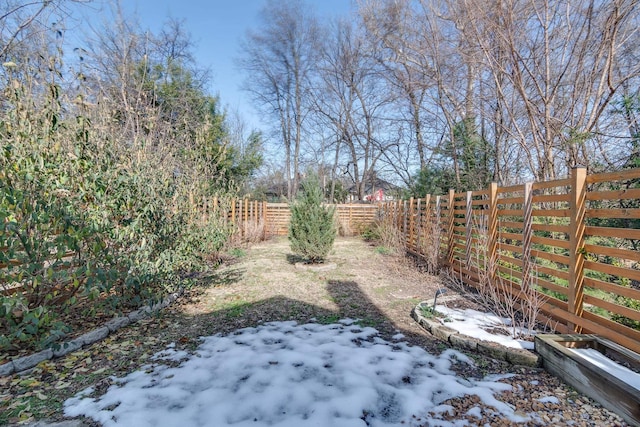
[{"left": 175, "top": 238, "right": 440, "bottom": 345}]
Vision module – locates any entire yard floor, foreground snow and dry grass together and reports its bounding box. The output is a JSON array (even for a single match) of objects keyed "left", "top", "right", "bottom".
[{"left": 0, "top": 239, "right": 626, "bottom": 427}]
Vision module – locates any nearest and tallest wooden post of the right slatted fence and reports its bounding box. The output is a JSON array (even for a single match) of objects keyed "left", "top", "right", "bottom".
[{"left": 567, "top": 167, "right": 587, "bottom": 333}]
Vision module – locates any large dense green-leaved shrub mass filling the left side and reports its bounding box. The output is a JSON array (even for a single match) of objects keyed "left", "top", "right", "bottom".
[{"left": 0, "top": 35, "right": 248, "bottom": 351}]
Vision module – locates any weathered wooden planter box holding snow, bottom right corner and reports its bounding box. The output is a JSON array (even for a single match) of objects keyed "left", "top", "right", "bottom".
[{"left": 535, "top": 335, "right": 640, "bottom": 426}]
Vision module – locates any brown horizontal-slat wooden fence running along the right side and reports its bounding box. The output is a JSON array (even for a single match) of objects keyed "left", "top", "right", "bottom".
[{"left": 382, "top": 168, "right": 640, "bottom": 352}]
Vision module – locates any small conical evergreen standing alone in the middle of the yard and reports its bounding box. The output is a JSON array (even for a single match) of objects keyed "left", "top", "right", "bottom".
[{"left": 289, "top": 177, "right": 336, "bottom": 263}]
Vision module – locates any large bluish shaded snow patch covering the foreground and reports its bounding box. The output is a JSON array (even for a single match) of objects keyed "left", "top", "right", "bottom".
[{"left": 64, "top": 320, "right": 530, "bottom": 427}]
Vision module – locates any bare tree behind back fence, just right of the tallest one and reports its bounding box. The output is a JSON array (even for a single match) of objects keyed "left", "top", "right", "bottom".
[{"left": 314, "top": 17, "right": 390, "bottom": 200}]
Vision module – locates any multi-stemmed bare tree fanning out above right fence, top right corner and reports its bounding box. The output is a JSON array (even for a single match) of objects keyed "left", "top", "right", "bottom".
[{"left": 464, "top": 0, "right": 640, "bottom": 180}]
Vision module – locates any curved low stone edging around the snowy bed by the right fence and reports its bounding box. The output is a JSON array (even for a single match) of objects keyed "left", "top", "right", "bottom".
[{"left": 411, "top": 298, "right": 542, "bottom": 367}]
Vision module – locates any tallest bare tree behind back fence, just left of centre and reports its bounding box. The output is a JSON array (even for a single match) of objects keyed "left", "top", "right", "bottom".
[{"left": 238, "top": 0, "right": 320, "bottom": 199}]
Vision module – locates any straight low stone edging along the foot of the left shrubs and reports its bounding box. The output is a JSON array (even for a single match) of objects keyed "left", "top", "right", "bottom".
[{"left": 0, "top": 289, "right": 184, "bottom": 377}]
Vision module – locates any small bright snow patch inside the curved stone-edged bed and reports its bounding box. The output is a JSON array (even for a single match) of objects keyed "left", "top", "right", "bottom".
[{"left": 436, "top": 305, "right": 534, "bottom": 350}]
